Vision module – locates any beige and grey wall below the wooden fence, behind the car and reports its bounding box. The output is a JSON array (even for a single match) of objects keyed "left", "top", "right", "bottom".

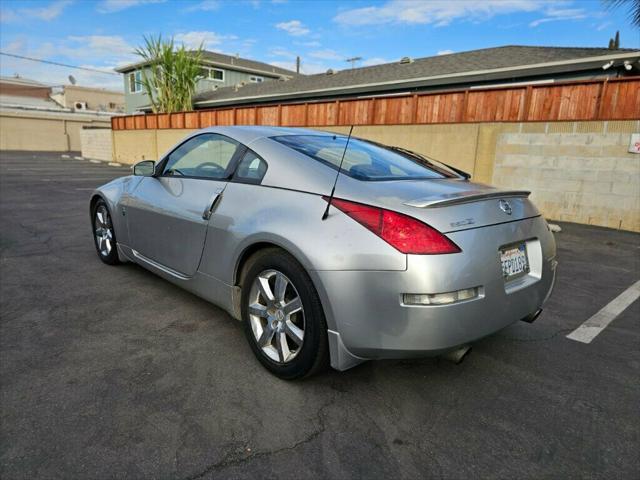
[{"left": 113, "top": 120, "right": 640, "bottom": 231}]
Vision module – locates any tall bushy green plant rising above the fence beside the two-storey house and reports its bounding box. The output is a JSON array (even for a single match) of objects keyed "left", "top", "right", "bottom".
[{"left": 135, "top": 35, "right": 203, "bottom": 113}]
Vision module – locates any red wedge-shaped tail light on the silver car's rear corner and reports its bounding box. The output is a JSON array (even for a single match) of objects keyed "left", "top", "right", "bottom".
[{"left": 322, "top": 197, "right": 462, "bottom": 255}]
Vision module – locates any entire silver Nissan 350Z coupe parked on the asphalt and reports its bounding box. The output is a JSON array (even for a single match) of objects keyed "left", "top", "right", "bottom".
[{"left": 90, "top": 127, "right": 557, "bottom": 379}]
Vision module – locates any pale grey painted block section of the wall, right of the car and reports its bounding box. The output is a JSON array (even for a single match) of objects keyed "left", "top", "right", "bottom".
[{"left": 492, "top": 121, "right": 640, "bottom": 231}]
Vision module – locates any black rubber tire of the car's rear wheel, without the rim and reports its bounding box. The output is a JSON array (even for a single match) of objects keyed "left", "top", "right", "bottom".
[{"left": 241, "top": 248, "right": 329, "bottom": 380}]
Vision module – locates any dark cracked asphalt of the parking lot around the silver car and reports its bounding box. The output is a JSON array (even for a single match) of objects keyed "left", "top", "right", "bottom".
[{"left": 0, "top": 151, "right": 640, "bottom": 479}]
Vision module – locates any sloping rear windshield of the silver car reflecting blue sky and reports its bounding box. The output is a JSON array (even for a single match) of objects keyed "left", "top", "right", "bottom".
[{"left": 271, "top": 135, "right": 457, "bottom": 181}]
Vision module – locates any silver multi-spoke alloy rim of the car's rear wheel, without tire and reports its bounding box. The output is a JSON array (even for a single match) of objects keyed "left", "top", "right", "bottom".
[{"left": 248, "top": 270, "right": 305, "bottom": 363}]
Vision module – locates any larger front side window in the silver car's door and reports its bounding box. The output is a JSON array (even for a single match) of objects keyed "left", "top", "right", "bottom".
[{"left": 162, "top": 133, "right": 238, "bottom": 180}]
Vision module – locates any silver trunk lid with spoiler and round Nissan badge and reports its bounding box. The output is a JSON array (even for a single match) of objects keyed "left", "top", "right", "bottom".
[{"left": 336, "top": 177, "right": 540, "bottom": 233}]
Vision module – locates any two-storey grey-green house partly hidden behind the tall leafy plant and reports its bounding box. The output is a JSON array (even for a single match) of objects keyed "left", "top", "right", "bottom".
[{"left": 116, "top": 51, "right": 298, "bottom": 113}]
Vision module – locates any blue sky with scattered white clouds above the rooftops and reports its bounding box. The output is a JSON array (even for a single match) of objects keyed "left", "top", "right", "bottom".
[{"left": 0, "top": 0, "right": 640, "bottom": 89}]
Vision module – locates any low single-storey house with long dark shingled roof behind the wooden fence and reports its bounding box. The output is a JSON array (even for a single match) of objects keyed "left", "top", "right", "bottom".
[{"left": 194, "top": 46, "right": 640, "bottom": 109}]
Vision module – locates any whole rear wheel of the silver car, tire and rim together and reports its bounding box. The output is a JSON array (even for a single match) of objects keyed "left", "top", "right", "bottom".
[{"left": 242, "top": 248, "right": 328, "bottom": 380}]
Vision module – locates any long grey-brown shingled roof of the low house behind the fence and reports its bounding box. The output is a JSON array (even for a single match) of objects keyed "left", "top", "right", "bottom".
[{"left": 195, "top": 46, "right": 640, "bottom": 106}]
